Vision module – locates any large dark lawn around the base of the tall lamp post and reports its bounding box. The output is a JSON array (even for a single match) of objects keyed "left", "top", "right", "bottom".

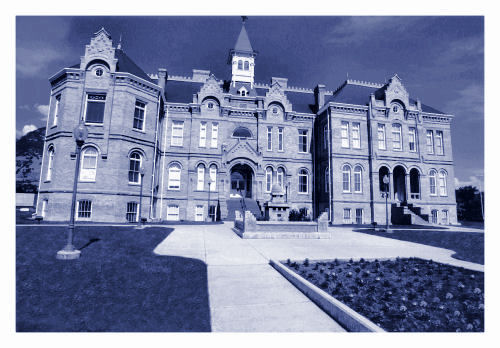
[{"left": 16, "top": 225, "right": 211, "bottom": 332}]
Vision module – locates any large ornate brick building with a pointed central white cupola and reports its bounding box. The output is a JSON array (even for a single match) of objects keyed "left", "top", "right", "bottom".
[{"left": 37, "top": 24, "right": 457, "bottom": 224}]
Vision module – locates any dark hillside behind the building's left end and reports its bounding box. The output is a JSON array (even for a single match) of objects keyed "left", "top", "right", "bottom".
[{"left": 16, "top": 127, "right": 45, "bottom": 193}]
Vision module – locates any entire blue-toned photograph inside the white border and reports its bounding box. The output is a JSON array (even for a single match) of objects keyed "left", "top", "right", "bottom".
[{"left": 15, "top": 15, "right": 485, "bottom": 333}]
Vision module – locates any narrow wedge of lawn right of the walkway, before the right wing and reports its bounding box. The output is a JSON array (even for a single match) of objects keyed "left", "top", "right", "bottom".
[{"left": 354, "top": 229, "right": 484, "bottom": 265}]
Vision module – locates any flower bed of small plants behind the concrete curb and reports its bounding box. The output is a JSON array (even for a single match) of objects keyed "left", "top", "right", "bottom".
[{"left": 286, "top": 258, "right": 484, "bottom": 332}]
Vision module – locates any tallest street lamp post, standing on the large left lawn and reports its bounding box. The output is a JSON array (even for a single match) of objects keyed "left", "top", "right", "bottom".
[{"left": 56, "top": 122, "right": 88, "bottom": 260}]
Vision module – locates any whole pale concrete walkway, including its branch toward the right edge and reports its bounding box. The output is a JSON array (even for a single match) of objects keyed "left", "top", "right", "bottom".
[{"left": 154, "top": 222, "right": 484, "bottom": 332}]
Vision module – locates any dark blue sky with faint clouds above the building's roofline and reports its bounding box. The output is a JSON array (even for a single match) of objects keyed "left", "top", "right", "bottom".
[{"left": 16, "top": 16, "right": 484, "bottom": 188}]
